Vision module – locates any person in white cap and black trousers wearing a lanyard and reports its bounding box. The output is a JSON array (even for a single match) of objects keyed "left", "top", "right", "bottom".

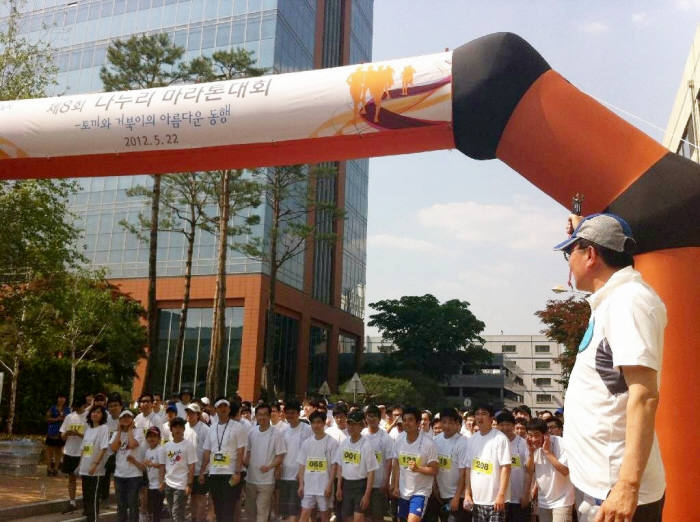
[{"left": 199, "top": 397, "right": 248, "bottom": 520}]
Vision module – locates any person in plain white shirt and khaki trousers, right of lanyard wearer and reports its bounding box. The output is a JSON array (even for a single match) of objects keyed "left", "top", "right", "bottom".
[{"left": 243, "top": 404, "right": 287, "bottom": 522}]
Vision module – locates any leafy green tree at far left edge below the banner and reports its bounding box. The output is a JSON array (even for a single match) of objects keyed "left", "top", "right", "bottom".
[{"left": 0, "top": 180, "right": 84, "bottom": 433}]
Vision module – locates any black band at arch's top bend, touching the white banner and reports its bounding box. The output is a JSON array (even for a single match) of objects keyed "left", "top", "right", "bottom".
[{"left": 452, "top": 33, "right": 550, "bottom": 159}]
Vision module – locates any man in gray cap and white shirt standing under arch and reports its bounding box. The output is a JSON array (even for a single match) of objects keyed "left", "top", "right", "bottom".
[{"left": 554, "top": 214, "right": 666, "bottom": 522}]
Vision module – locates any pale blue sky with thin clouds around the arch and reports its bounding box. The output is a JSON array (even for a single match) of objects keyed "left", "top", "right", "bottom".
[{"left": 366, "top": 0, "right": 700, "bottom": 335}]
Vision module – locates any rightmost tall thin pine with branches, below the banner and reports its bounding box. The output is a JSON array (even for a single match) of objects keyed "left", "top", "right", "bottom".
[{"left": 241, "top": 165, "right": 344, "bottom": 400}]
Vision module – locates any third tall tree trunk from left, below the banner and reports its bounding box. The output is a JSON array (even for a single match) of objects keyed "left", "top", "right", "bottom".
[{"left": 206, "top": 170, "right": 231, "bottom": 398}]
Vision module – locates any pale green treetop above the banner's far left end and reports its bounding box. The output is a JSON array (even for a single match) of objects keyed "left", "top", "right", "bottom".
[{"left": 0, "top": 0, "right": 58, "bottom": 101}]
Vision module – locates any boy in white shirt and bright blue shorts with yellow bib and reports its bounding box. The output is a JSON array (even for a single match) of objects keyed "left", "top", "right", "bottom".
[{"left": 391, "top": 407, "right": 439, "bottom": 522}]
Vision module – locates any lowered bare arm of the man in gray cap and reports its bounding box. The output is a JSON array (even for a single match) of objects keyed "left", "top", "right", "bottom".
[{"left": 596, "top": 366, "right": 659, "bottom": 520}]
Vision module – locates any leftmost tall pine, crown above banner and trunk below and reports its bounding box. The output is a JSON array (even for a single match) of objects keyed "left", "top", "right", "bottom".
[{"left": 100, "top": 33, "right": 187, "bottom": 385}]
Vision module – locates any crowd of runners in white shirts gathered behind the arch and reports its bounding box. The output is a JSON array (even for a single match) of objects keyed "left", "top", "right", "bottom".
[{"left": 47, "top": 390, "right": 574, "bottom": 522}]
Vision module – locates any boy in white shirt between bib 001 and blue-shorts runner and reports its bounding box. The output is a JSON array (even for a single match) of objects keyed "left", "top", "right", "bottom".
[{"left": 362, "top": 406, "right": 396, "bottom": 522}]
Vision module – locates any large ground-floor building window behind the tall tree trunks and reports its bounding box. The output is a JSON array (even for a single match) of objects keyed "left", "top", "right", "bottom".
[{"left": 151, "top": 306, "right": 243, "bottom": 397}]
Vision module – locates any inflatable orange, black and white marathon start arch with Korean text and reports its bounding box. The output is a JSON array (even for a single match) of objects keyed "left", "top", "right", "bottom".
[{"left": 0, "top": 33, "right": 700, "bottom": 522}]
